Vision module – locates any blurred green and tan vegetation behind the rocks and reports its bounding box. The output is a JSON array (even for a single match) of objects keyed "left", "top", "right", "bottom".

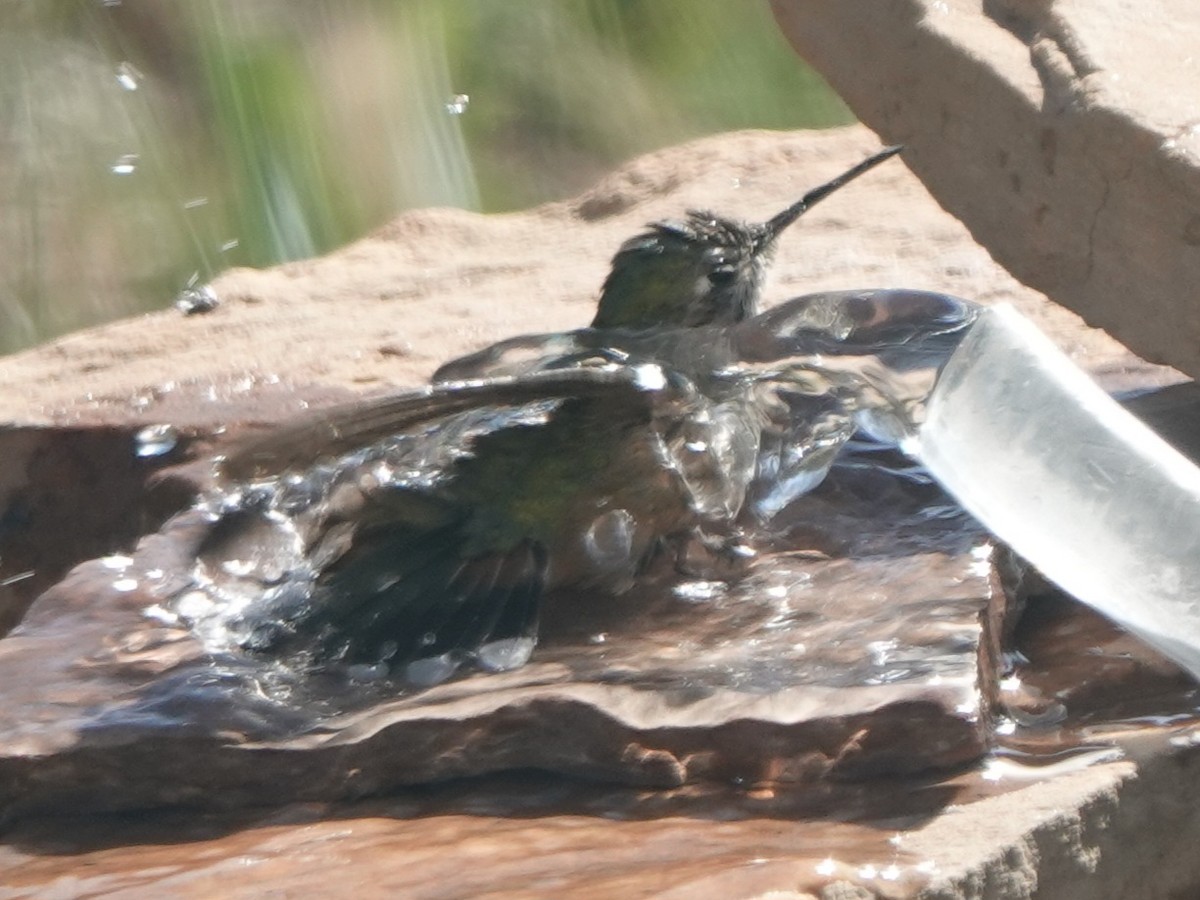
[{"left": 0, "top": 0, "right": 851, "bottom": 352}]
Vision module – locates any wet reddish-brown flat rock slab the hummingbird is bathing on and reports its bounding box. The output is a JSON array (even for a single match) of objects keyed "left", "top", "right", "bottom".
[{"left": 0, "top": 441, "right": 1002, "bottom": 815}]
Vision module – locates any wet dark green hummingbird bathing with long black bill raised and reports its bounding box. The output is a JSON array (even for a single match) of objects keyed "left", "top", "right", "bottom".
[{"left": 221, "top": 148, "right": 900, "bottom": 684}]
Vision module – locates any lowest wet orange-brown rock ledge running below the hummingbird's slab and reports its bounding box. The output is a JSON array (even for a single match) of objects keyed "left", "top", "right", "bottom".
[{"left": 0, "top": 592, "right": 1200, "bottom": 900}]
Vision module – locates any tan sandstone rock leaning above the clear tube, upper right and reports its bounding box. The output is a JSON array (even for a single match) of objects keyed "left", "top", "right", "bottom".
[{"left": 773, "top": 0, "right": 1200, "bottom": 376}]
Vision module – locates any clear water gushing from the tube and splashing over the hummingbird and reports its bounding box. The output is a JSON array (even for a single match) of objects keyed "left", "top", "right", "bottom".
[{"left": 166, "top": 286, "right": 973, "bottom": 686}]
